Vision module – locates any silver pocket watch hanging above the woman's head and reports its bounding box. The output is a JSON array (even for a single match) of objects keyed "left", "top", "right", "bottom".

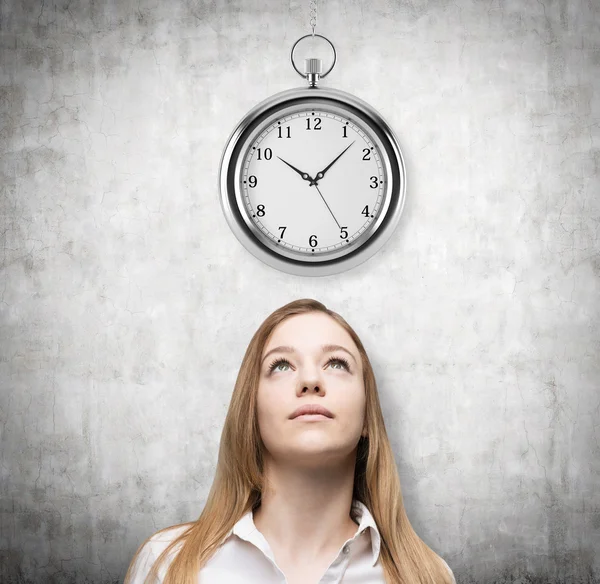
[{"left": 219, "top": 31, "right": 406, "bottom": 276}]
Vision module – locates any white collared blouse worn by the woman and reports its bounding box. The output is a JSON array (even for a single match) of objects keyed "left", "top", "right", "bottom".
[{"left": 131, "top": 500, "right": 456, "bottom": 584}]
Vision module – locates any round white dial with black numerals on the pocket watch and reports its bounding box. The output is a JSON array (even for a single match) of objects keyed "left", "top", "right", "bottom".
[{"left": 235, "top": 100, "right": 389, "bottom": 261}]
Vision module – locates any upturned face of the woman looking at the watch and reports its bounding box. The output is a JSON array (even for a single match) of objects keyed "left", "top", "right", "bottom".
[{"left": 257, "top": 312, "right": 366, "bottom": 466}]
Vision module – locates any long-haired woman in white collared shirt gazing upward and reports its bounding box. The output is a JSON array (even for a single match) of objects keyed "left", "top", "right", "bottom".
[{"left": 124, "top": 299, "right": 455, "bottom": 584}]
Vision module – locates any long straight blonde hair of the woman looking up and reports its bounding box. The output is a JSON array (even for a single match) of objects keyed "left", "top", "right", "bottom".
[{"left": 124, "top": 298, "right": 452, "bottom": 584}]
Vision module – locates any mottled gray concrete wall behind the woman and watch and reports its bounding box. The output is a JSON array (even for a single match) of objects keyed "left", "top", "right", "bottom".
[{"left": 0, "top": 0, "right": 600, "bottom": 584}]
